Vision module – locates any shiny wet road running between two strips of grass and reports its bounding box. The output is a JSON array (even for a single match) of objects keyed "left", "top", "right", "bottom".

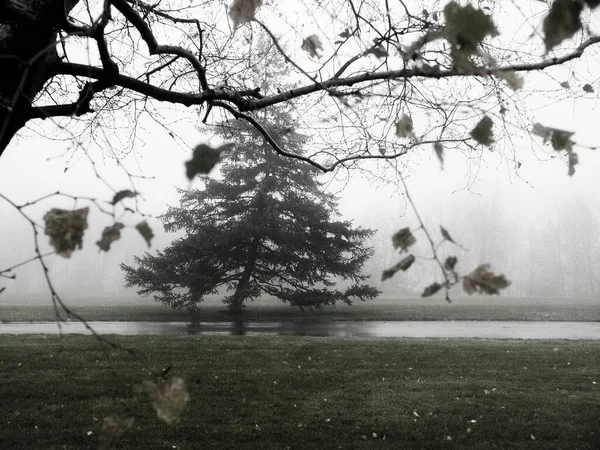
[{"left": 0, "top": 321, "right": 600, "bottom": 340}]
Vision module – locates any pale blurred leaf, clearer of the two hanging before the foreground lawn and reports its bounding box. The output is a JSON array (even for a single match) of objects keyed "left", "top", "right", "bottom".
[{"left": 140, "top": 377, "right": 190, "bottom": 425}]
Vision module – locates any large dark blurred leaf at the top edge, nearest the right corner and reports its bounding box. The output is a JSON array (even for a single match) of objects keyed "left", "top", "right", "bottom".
[{"left": 542, "top": 0, "right": 583, "bottom": 52}]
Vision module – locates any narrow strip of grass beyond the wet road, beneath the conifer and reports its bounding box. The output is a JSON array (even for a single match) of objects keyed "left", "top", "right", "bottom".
[{"left": 0, "top": 297, "right": 600, "bottom": 322}]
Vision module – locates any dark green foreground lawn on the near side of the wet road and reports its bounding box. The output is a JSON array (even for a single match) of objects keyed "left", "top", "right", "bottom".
[{"left": 0, "top": 336, "right": 600, "bottom": 450}]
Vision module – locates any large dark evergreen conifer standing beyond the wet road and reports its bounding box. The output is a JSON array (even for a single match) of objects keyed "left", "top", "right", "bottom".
[{"left": 121, "top": 111, "right": 379, "bottom": 314}]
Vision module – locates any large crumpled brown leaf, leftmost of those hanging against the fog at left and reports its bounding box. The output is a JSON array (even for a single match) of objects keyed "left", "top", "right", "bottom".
[{"left": 44, "top": 208, "right": 89, "bottom": 258}]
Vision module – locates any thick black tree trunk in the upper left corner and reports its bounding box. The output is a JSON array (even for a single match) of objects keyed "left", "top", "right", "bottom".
[{"left": 0, "top": 0, "right": 79, "bottom": 156}]
